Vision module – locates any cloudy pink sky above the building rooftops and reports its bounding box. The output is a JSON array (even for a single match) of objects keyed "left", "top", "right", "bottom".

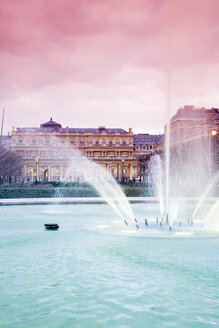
[{"left": 0, "top": 0, "right": 219, "bottom": 133}]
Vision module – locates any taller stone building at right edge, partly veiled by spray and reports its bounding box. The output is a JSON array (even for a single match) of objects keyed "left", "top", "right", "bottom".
[{"left": 170, "top": 106, "right": 219, "bottom": 190}]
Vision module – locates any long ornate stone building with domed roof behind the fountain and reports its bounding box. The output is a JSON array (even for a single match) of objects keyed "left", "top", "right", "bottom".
[{"left": 11, "top": 118, "right": 163, "bottom": 181}]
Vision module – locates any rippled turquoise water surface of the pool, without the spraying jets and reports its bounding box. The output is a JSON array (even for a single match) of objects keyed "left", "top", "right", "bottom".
[{"left": 0, "top": 204, "right": 219, "bottom": 328}]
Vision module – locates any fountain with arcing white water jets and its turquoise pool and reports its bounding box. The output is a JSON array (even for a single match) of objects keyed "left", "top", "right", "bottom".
[{"left": 0, "top": 121, "right": 219, "bottom": 328}]
